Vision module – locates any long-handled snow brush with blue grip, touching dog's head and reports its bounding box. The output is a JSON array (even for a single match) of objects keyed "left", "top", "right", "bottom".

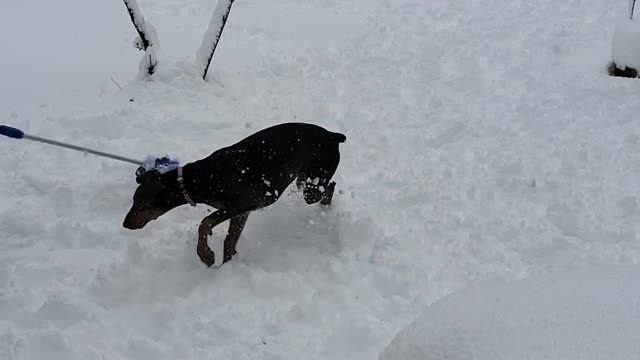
[{"left": 0, "top": 125, "right": 180, "bottom": 177}]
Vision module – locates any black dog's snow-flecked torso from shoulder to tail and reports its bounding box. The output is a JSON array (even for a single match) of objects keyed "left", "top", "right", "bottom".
[{"left": 193, "top": 123, "right": 346, "bottom": 207}]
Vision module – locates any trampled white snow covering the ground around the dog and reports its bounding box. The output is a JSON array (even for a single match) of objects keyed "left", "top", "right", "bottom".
[{"left": 0, "top": 0, "right": 640, "bottom": 360}]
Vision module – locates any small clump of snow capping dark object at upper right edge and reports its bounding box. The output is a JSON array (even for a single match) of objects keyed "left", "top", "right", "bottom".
[{"left": 611, "top": 19, "right": 640, "bottom": 69}]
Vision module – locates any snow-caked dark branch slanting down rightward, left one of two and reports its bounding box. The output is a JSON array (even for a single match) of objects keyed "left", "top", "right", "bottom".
[{"left": 123, "top": 0, "right": 160, "bottom": 76}]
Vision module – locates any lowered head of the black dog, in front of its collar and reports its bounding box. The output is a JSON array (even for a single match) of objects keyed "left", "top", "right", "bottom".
[{"left": 122, "top": 170, "right": 177, "bottom": 230}]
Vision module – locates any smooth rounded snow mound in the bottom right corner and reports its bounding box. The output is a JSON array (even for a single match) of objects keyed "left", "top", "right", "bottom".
[{"left": 380, "top": 266, "right": 640, "bottom": 360}]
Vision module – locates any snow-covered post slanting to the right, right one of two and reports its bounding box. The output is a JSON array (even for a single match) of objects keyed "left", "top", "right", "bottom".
[{"left": 195, "top": 0, "right": 235, "bottom": 79}]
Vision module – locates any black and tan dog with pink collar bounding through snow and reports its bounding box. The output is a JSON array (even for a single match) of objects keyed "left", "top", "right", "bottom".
[{"left": 122, "top": 123, "right": 347, "bottom": 267}]
